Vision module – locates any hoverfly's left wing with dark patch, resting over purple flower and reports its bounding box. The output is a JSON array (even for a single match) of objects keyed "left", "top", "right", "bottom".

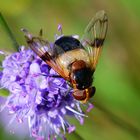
[{"left": 23, "top": 29, "right": 69, "bottom": 81}]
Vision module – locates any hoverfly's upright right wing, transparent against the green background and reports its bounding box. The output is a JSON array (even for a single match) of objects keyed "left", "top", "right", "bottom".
[{"left": 81, "top": 11, "right": 108, "bottom": 69}]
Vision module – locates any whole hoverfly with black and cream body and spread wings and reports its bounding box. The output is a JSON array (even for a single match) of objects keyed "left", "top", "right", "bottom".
[{"left": 24, "top": 11, "right": 108, "bottom": 103}]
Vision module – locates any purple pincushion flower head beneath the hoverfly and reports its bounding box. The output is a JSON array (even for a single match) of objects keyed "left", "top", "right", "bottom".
[{"left": 0, "top": 27, "right": 93, "bottom": 140}]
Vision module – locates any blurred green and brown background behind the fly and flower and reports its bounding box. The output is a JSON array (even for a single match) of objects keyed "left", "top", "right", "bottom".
[{"left": 0, "top": 0, "right": 140, "bottom": 140}]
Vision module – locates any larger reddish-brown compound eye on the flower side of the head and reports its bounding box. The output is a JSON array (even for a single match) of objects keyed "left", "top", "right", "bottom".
[{"left": 73, "top": 90, "right": 86, "bottom": 101}]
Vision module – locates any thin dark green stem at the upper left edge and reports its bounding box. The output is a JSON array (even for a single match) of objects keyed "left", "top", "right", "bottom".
[{"left": 0, "top": 13, "right": 19, "bottom": 51}]
